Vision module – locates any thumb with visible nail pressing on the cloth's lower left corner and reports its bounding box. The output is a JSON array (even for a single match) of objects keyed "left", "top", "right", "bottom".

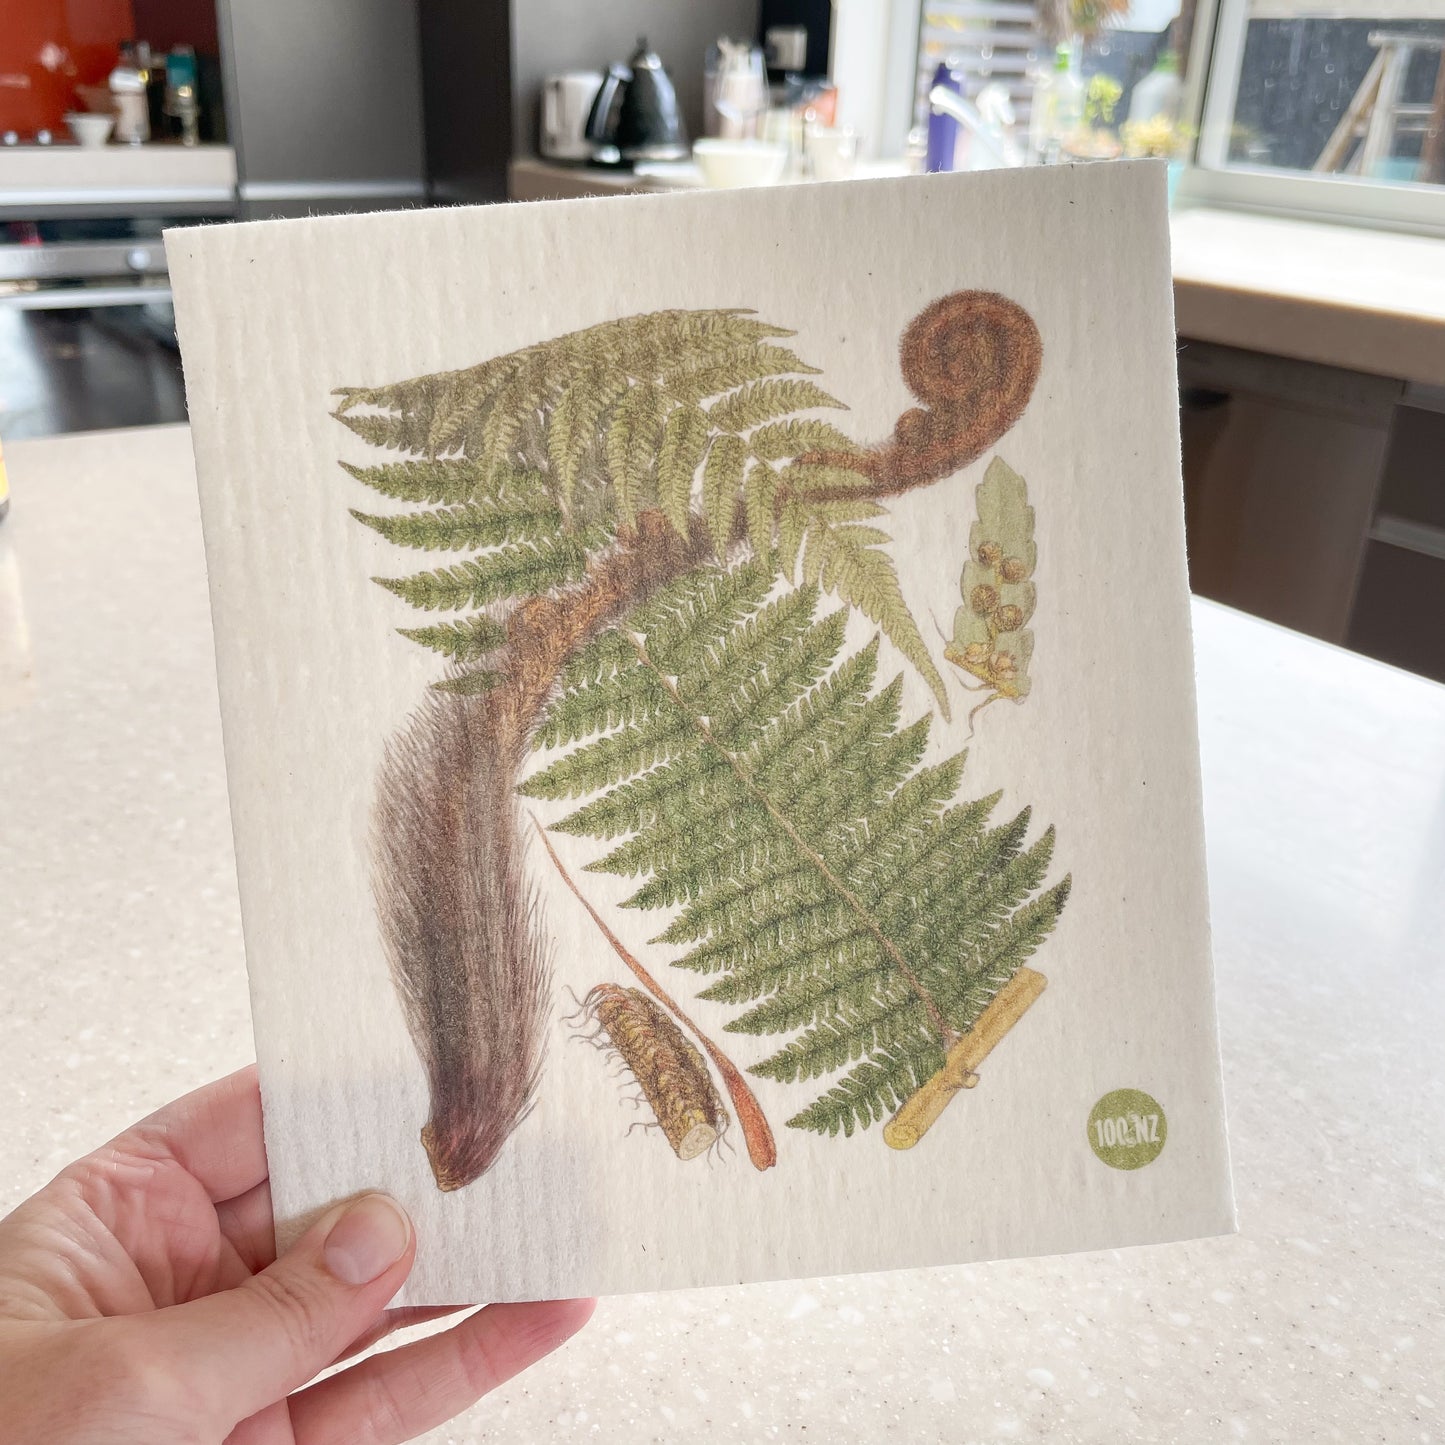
[{"left": 149, "top": 1194, "right": 416, "bottom": 1433}]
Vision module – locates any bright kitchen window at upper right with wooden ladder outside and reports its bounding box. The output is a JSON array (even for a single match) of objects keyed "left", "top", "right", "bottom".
[{"left": 906, "top": 0, "right": 1445, "bottom": 231}]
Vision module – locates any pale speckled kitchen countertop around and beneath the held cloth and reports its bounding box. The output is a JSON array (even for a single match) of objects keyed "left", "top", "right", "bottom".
[{"left": 0, "top": 428, "right": 1445, "bottom": 1445}]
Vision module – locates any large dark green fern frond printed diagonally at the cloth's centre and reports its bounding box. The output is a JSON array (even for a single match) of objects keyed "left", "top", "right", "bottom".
[{"left": 522, "top": 564, "right": 1069, "bottom": 1134}]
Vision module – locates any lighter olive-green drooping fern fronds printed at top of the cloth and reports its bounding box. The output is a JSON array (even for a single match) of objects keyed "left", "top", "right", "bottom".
[{"left": 337, "top": 311, "right": 948, "bottom": 714}]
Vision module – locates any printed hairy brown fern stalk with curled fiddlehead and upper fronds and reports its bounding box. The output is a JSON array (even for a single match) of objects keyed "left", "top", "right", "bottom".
[{"left": 335, "top": 292, "right": 1040, "bottom": 1189}]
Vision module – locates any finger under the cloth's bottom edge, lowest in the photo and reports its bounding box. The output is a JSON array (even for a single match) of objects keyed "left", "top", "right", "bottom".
[{"left": 290, "top": 1299, "right": 597, "bottom": 1445}]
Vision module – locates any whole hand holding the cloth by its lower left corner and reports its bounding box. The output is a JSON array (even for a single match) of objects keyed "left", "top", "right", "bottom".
[{"left": 0, "top": 1068, "right": 594, "bottom": 1445}]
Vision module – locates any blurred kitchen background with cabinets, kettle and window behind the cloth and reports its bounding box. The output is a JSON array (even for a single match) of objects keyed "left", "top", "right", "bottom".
[{"left": 0, "top": 0, "right": 1445, "bottom": 679}]
